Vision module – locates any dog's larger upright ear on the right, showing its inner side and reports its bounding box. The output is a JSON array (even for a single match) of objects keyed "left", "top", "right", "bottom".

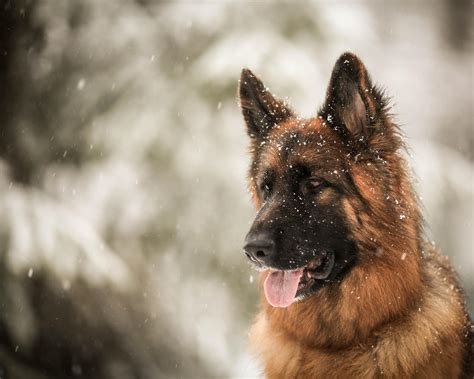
[{"left": 320, "top": 53, "right": 387, "bottom": 146}]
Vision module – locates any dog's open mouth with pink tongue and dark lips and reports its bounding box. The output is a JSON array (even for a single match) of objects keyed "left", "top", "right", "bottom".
[{"left": 263, "top": 252, "right": 335, "bottom": 308}]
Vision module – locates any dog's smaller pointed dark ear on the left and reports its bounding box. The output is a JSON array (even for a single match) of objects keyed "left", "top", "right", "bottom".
[{"left": 239, "top": 69, "right": 293, "bottom": 138}]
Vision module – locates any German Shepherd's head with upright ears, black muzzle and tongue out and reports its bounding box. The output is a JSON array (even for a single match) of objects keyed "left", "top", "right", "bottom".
[{"left": 240, "top": 53, "right": 410, "bottom": 307}]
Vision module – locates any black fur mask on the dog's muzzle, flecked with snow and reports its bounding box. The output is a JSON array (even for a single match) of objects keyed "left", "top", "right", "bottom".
[{"left": 249, "top": 156, "right": 356, "bottom": 284}]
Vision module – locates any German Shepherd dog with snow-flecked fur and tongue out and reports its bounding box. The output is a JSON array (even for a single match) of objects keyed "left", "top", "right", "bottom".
[{"left": 239, "top": 53, "right": 473, "bottom": 379}]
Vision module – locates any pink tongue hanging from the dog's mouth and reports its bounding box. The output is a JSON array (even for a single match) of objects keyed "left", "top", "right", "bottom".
[{"left": 263, "top": 270, "right": 303, "bottom": 308}]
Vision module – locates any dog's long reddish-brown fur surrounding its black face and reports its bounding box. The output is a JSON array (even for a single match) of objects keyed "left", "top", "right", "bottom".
[{"left": 243, "top": 52, "right": 471, "bottom": 378}]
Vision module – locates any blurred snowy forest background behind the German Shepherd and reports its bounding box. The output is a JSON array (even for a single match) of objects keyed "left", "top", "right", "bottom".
[{"left": 0, "top": 0, "right": 474, "bottom": 379}]
